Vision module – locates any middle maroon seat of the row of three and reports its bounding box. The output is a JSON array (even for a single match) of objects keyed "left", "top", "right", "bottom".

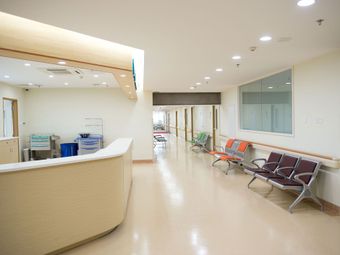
[{"left": 255, "top": 154, "right": 299, "bottom": 181}]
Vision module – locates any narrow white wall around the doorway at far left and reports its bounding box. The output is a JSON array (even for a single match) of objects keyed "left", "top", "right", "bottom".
[{"left": 0, "top": 82, "right": 25, "bottom": 153}]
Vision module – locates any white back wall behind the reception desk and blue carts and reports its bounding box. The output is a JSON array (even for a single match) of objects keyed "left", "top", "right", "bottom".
[{"left": 25, "top": 88, "right": 153, "bottom": 160}]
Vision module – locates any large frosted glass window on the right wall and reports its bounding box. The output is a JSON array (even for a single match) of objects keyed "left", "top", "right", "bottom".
[{"left": 240, "top": 70, "right": 292, "bottom": 134}]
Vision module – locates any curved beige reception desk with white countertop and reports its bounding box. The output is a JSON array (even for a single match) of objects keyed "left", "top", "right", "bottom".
[{"left": 0, "top": 138, "right": 132, "bottom": 255}]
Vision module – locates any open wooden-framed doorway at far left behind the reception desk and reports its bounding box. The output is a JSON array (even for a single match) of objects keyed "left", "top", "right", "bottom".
[{"left": 3, "top": 98, "right": 19, "bottom": 137}]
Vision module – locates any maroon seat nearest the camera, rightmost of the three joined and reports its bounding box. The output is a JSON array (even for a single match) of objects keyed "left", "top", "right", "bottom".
[{"left": 268, "top": 158, "right": 323, "bottom": 213}]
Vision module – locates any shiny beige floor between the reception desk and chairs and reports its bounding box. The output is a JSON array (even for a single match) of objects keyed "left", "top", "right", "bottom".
[{"left": 65, "top": 138, "right": 340, "bottom": 255}]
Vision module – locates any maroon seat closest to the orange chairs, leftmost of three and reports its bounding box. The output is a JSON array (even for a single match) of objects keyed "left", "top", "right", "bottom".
[{"left": 243, "top": 152, "right": 283, "bottom": 188}]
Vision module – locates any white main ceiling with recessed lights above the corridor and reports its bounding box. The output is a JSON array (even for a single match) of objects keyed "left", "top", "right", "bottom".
[{"left": 0, "top": 0, "right": 340, "bottom": 92}]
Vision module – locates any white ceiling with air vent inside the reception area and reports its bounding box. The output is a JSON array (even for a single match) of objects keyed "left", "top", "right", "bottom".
[{"left": 0, "top": 57, "right": 119, "bottom": 88}]
